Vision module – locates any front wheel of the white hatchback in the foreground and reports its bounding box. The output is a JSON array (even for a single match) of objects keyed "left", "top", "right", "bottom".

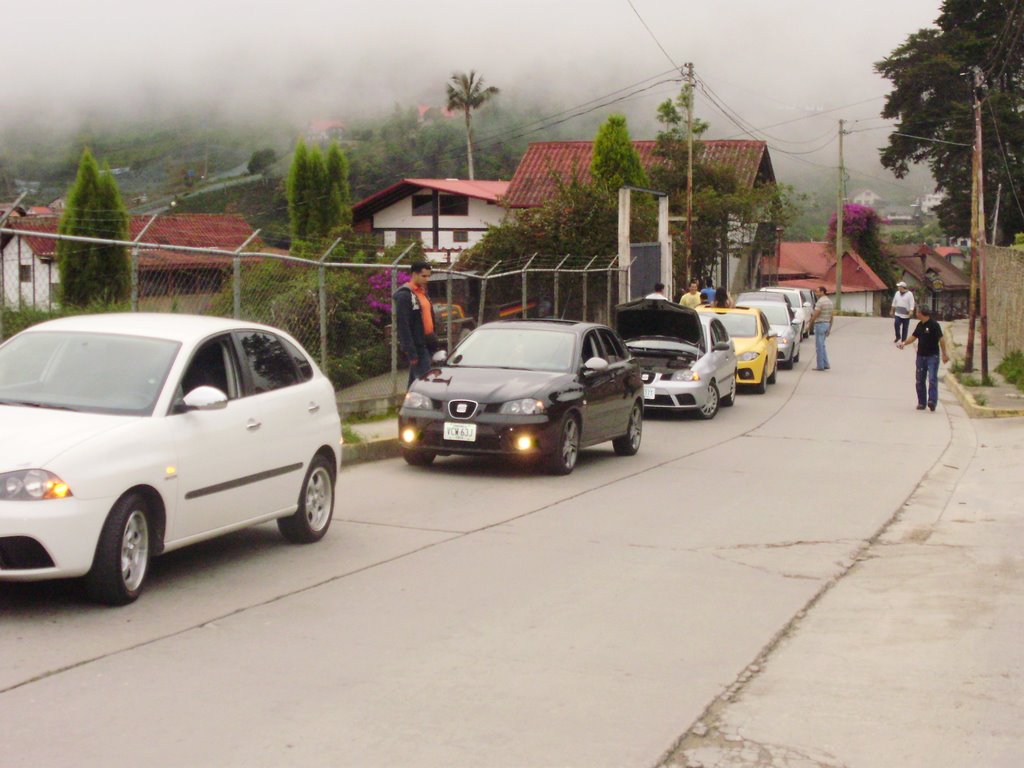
[{"left": 85, "top": 494, "right": 150, "bottom": 605}]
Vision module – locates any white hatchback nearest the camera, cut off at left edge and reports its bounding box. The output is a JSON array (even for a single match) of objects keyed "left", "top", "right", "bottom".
[{"left": 0, "top": 314, "right": 341, "bottom": 605}]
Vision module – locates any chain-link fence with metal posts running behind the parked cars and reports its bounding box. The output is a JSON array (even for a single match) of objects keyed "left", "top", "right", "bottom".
[{"left": 0, "top": 227, "right": 620, "bottom": 403}]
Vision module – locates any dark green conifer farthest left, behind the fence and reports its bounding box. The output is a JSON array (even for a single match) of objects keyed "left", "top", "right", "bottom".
[{"left": 56, "top": 150, "right": 131, "bottom": 306}]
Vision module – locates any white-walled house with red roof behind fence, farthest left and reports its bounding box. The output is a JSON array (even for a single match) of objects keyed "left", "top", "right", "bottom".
[{"left": 0, "top": 213, "right": 259, "bottom": 309}]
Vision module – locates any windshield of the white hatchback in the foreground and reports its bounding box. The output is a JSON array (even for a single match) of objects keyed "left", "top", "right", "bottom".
[{"left": 0, "top": 331, "right": 180, "bottom": 416}]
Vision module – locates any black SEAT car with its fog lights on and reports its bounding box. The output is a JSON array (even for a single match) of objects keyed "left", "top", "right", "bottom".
[{"left": 398, "top": 321, "right": 643, "bottom": 474}]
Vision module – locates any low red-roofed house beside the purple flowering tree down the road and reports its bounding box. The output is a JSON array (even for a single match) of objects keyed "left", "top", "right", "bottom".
[{"left": 761, "top": 243, "right": 889, "bottom": 315}]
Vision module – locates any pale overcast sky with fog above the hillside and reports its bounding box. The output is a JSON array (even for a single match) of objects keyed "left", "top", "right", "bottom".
[{"left": 6, "top": 0, "right": 941, "bottom": 185}]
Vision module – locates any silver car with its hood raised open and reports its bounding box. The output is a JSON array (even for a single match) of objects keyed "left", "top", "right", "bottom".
[{"left": 615, "top": 299, "right": 736, "bottom": 419}]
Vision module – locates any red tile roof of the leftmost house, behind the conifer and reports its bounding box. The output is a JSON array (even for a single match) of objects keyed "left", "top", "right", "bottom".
[{"left": 7, "top": 213, "right": 260, "bottom": 270}]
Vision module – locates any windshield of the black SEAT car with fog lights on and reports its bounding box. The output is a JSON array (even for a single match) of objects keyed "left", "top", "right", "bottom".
[{"left": 449, "top": 328, "right": 575, "bottom": 371}]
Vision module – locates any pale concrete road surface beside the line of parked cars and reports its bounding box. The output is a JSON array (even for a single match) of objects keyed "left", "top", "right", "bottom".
[{"left": 0, "top": 318, "right": 1024, "bottom": 768}]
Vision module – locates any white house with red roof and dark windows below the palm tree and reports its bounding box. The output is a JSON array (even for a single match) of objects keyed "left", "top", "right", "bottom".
[{"left": 352, "top": 178, "right": 509, "bottom": 261}]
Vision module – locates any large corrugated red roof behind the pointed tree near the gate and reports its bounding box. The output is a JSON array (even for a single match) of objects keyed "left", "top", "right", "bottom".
[{"left": 503, "top": 139, "right": 775, "bottom": 208}]
